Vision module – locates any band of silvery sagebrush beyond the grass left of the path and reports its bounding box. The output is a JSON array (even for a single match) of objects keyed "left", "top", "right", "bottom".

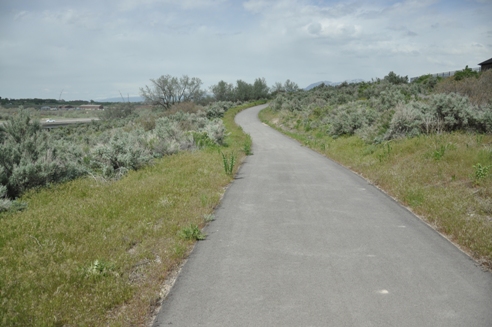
[{"left": 0, "top": 102, "right": 234, "bottom": 201}]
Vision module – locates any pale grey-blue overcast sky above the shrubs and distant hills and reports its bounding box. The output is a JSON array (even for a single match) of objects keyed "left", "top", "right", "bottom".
[{"left": 0, "top": 0, "right": 492, "bottom": 100}]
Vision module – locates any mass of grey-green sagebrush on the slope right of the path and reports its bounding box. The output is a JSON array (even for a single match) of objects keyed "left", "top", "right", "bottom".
[{"left": 270, "top": 70, "right": 492, "bottom": 143}]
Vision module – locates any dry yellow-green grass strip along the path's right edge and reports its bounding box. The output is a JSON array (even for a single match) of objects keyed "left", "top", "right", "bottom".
[{"left": 260, "top": 109, "right": 492, "bottom": 269}]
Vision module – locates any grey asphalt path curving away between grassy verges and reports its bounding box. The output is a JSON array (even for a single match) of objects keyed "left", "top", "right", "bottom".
[{"left": 154, "top": 106, "right": 492, "bottom": 327}]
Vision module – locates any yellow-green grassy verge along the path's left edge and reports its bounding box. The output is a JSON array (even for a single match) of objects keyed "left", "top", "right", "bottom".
[{"left": 0, "top": 101, "right": 262, "bottom": 326}]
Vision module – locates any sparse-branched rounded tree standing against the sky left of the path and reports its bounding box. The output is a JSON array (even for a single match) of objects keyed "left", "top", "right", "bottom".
[{"left": 140, "top": 75, "right": 205, "bottom": 109}]
